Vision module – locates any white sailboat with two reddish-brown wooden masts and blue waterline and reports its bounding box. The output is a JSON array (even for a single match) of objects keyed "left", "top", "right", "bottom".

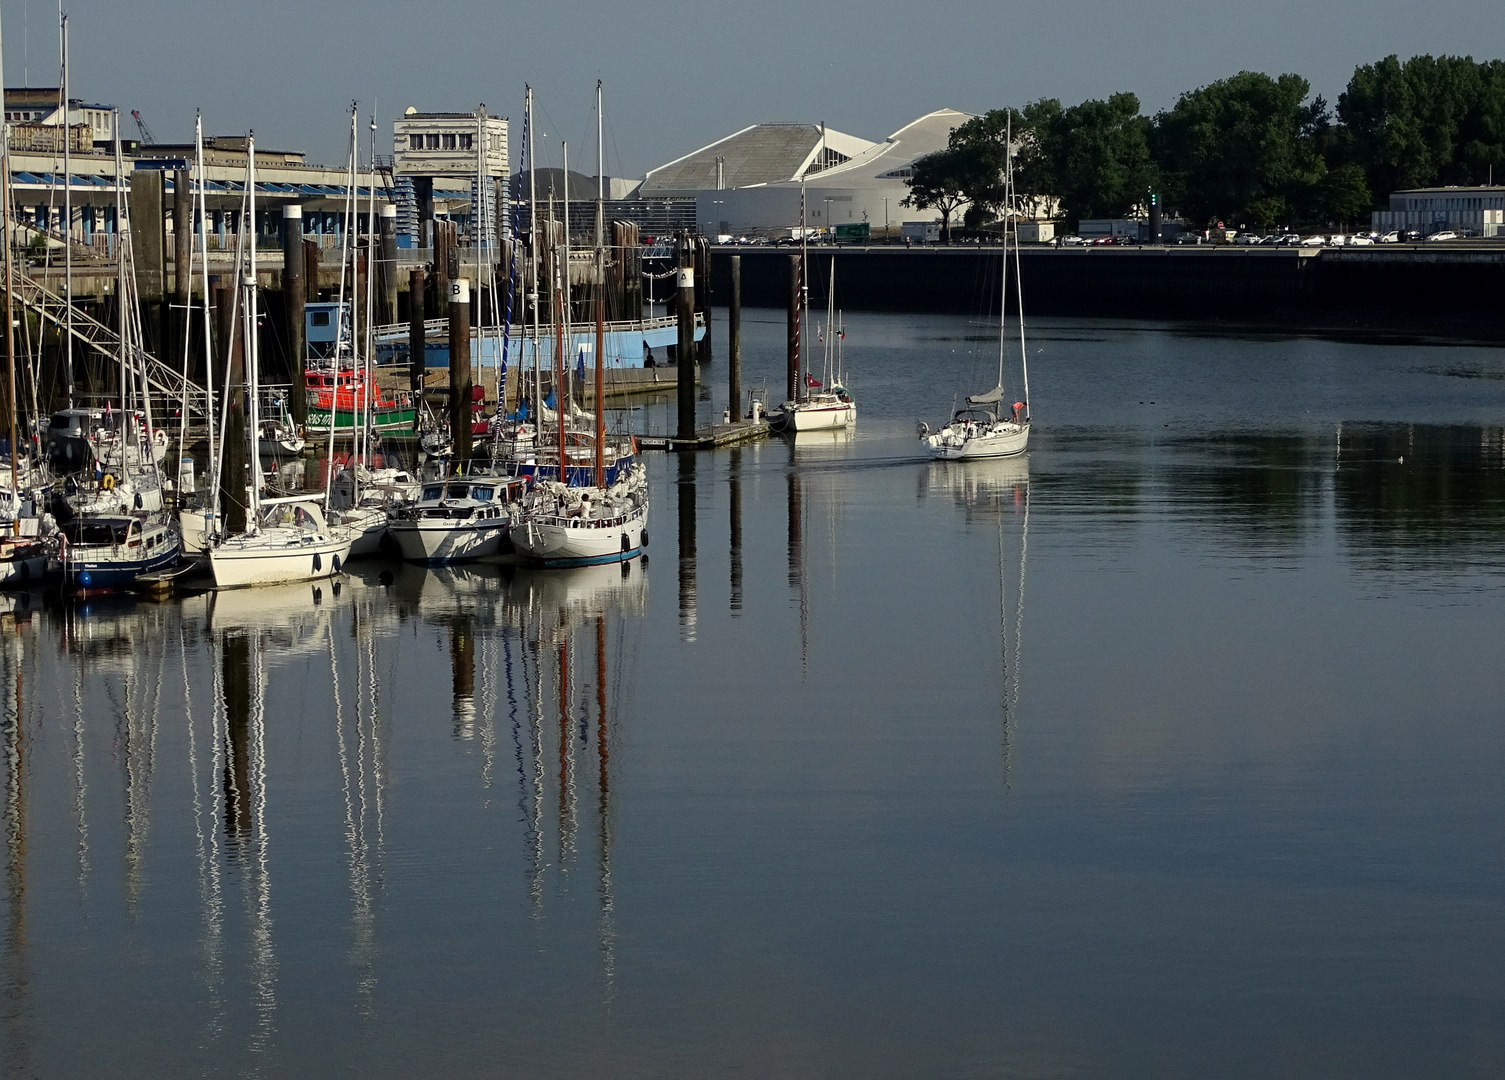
[{"left": 512, "top": 83, "right": 649, "bottom": 567}]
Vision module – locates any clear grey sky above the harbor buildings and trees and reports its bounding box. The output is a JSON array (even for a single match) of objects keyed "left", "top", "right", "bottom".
[{"left": 11, "top": 0, "right": 1505, "bottom": 176}]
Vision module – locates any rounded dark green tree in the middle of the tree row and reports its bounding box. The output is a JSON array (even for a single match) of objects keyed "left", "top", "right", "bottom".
[{"left": 1154, "top": 71, "right": 1326, "bottom": 229}]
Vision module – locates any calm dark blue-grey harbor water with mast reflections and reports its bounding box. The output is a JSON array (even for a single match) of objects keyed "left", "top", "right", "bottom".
[{"left": 0, "top": 311, "right": 1505, "bottom": 1078}]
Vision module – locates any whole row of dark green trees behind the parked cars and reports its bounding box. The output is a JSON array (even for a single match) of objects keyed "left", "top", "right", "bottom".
[{"left": 908, "top": 56, "right": 1505, "bottom": 233}]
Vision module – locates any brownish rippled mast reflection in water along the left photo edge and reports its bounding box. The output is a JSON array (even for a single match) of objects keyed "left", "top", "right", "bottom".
[{"left": 0, "top": 635, "right": 32, "bottom": 1075}]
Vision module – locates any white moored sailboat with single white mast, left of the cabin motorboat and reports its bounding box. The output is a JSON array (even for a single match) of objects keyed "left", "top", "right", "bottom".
[{"left": 209, "top": 135, "right": 351, "bottom": 588}]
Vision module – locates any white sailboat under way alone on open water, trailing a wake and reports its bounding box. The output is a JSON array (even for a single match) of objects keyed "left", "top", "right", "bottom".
[{"left": 920, "top": 117, "right": 1029, "bottom": 462}]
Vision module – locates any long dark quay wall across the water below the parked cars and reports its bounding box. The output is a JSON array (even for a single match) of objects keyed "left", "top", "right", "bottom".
[{"left": 712, "top": 244, "right": 1505, "bottom": 327}]
